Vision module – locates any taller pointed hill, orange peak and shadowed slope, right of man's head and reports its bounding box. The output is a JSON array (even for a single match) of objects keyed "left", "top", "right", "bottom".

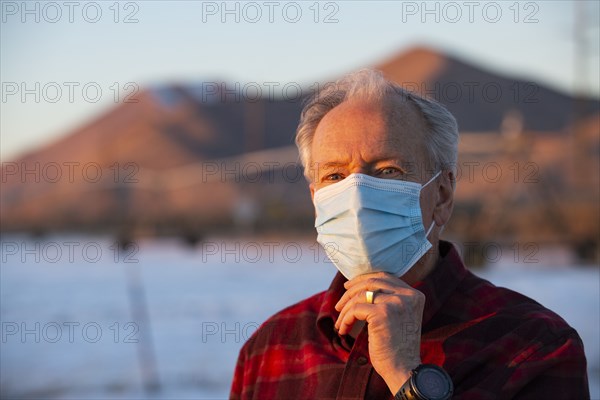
[{"left": 375, "top": 47, "right": 600, "bottom": 132}]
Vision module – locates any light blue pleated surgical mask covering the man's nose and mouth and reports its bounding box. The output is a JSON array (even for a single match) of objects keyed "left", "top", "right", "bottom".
[{"left": 314, "top": 172, "right": 440, "bottom": 279}]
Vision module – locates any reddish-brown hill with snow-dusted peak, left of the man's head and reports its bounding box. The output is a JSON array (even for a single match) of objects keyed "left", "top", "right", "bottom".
[{"left": 0, "top": 86, "right": 300, "bottom": 231}]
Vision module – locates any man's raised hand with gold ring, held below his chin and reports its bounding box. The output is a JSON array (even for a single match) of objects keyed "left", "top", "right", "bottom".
[{"left": 335, "top": 272, "right": 425, "bottom": 394}]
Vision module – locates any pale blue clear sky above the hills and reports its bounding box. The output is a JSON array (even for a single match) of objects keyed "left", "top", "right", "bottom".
[{"left": 0, "top": 0, "right": 600, "bottom": 161}]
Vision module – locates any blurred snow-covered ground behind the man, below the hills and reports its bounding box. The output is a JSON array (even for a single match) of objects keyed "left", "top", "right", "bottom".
[{"left": 0, "top": 236, "right": 600, "bottom": 399}]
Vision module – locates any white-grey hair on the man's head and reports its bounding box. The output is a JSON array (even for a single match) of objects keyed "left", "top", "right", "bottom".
[{"left": 296, "top": 69, "right": 458, "bottom": 181}]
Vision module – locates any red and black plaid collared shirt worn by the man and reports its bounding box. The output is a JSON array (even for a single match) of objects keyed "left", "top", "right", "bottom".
[{"left": 230, "top": 241, "right": 589, "bottom": 400}]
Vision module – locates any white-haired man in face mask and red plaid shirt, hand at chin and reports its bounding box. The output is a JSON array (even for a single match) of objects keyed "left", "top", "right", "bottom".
[{"left": 231, "top": 70, "right": 589, "bottom": 400}]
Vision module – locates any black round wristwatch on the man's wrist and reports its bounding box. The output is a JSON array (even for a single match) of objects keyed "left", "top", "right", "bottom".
[{"left": 394, "top": 364, "right": 454, "bottom": 400}]
